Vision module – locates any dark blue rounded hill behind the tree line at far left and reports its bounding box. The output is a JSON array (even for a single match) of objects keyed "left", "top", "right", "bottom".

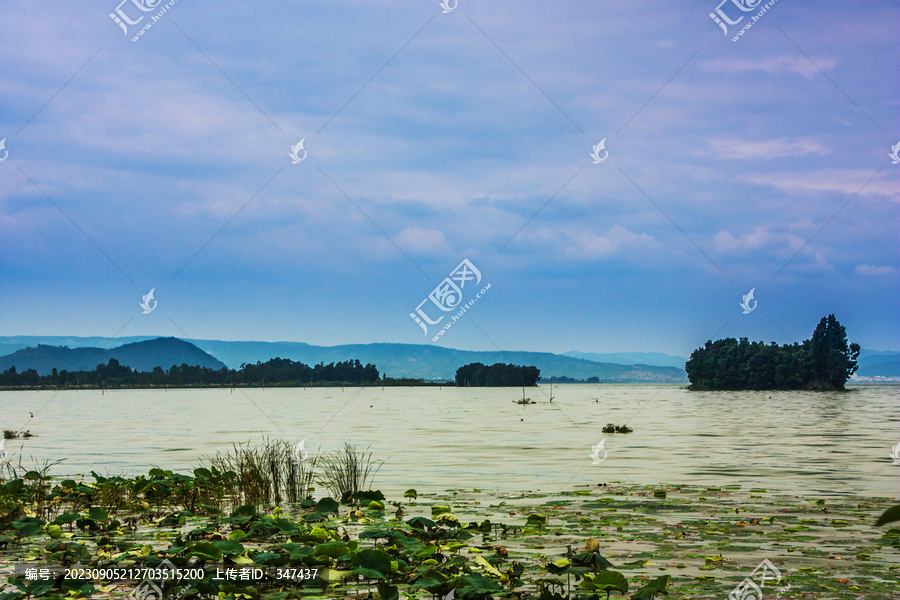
[{"left": 0, "top": 338, "right": 225, "bottom": 375}]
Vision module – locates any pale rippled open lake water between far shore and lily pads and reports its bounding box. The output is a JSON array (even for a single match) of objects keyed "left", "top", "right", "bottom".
[{"left": 0, "top": 384, "right": 900, "bottom": 496}]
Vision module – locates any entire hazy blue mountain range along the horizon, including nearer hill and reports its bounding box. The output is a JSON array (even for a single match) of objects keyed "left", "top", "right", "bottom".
[{"left": 0, "top": 336, "right": 900, "bottom": 383}]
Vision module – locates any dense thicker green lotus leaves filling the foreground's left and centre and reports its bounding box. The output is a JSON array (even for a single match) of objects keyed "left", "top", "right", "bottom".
[{"left": 0, "top": 468, "right": 670, "bottom": 600}]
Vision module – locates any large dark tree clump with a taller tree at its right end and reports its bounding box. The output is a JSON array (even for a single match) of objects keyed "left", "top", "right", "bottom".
[{"left": 685, "top": 315, "right": 860, "bottom": 391}]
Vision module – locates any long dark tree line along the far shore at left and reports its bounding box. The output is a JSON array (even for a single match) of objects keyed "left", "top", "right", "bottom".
[{"left": 0, "top": 358, "right": 441, "bottom": 389}]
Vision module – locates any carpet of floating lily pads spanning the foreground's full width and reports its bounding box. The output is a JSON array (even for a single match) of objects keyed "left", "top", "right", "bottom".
[{"left": 0, "top": 452, "right": 900, "bottom": 600}]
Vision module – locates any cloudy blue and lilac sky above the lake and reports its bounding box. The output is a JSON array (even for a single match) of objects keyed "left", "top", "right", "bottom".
[{"left": 0, "top": 0, "right": 900, "bottom": 356}]
